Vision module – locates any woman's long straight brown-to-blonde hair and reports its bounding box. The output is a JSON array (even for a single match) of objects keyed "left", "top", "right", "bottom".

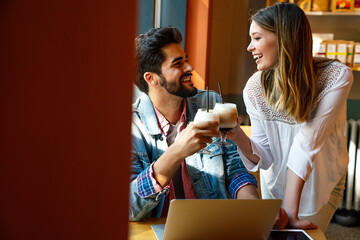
[{"left": 251, "top": 3, "right": 316, "bottom": 122}]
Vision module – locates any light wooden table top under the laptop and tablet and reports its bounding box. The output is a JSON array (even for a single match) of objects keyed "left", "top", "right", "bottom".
[{"left": 128, "top": 218, "right": 326, "bottom": 240}]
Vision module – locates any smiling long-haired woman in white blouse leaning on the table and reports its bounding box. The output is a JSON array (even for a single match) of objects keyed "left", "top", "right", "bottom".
[{"left": 229, "top": 3, "right": 353, "bottom": 232}]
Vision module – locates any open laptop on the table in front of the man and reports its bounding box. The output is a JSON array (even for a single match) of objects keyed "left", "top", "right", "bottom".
[{"left": 151, "top": 199, "right": 281, "bottom": 240}]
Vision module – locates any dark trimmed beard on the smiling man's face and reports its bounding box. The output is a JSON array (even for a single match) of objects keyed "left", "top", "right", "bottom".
[{"left": 159, "top": 73, "right": 197, "bottom": 98}]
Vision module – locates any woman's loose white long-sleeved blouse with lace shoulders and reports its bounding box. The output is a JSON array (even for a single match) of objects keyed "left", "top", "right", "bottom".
[{"left": 239, "top": 60, "right": 353, "bottom": 216}]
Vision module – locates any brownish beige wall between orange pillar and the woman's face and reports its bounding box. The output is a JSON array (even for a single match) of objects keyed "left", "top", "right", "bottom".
[{"left": 209, "top": 0, "right": 265, "bottom": 95}]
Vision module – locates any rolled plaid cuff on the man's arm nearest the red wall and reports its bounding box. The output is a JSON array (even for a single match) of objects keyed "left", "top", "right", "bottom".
[{"left": 136, "top": 163, "right": 170, "bottom": 198}]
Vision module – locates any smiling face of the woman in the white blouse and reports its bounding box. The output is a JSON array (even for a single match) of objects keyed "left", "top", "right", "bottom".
[{"left": 247, "top": 21, "right": 279, "bottom": 71}]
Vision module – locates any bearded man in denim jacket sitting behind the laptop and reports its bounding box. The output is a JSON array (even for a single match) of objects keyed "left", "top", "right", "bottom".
[{"left": 130, "top": 27, "right": 259, "bottom": 221}]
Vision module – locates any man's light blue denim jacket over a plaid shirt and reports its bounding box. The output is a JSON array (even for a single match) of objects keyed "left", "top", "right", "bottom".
[{"left": 129, "top": 90, "right": 257, "bottom": 221}]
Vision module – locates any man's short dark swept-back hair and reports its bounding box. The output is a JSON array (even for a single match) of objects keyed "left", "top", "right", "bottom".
[{"left": 135, "top": 27, "right": 182, "bottom": 94}]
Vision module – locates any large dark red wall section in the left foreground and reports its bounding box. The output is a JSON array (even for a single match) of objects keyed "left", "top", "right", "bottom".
[{"left": 0, "top": 0, "right": 136, "bottom": 239}]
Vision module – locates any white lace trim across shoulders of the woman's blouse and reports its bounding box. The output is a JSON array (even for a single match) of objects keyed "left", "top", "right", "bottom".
[{"left": 244, "top": 59, "right": 346, "bottom": 124}]
